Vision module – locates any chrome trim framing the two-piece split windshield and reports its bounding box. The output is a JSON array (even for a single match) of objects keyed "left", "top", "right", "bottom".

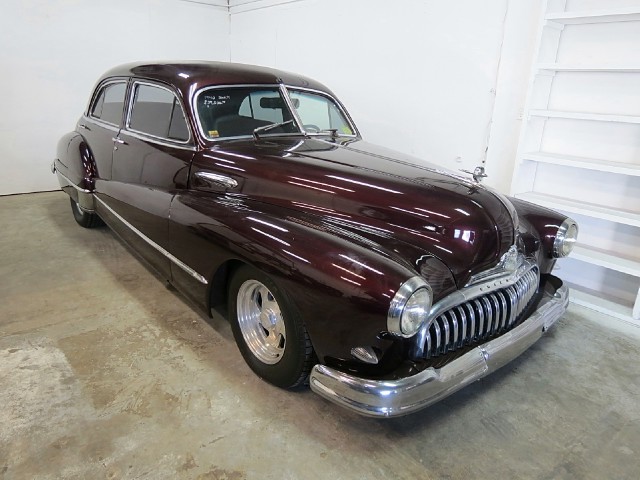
[{"left": 190, "top": 83, "right": 360, "bottom": 143}]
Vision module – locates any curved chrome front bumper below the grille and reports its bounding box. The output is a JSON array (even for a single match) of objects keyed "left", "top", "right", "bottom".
[{"left": 309, "top": 286, "right": 569, "bottom": 417}]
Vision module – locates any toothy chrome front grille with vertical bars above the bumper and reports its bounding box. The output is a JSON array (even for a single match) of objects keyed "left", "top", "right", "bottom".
[{"left": 423, "top": 268, "right": 538, "bottom": 358}]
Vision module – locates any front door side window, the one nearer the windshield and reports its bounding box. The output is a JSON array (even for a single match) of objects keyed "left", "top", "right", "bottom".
[{"left": 128, "top": 84, "right": 189, "bottom": 141}]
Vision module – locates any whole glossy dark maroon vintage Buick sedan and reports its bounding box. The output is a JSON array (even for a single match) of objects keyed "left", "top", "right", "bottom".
[{"left": 52, "top": 62, "right": 578, "bottom": 416}]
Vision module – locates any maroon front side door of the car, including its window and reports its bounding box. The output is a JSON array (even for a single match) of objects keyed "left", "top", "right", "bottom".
[{"left": 104, "top": 80, "right": 195, "bottom": 278}]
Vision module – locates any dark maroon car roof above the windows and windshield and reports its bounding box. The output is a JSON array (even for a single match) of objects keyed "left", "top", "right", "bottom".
[{"left": 98, "top": 61, "right": 331, "bottom": 97}]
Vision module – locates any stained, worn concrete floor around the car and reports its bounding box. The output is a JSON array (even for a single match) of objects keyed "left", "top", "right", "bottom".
[{"left": 0, "top": 192, "right": 640, "bottom": 480}]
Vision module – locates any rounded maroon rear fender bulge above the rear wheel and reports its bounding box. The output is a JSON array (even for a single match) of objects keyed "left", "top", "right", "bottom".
[{"left": 52, "top": 132, "right": 97, "bottom": 212}]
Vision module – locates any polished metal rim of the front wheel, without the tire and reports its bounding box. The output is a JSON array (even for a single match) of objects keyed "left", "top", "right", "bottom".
[{"left": 237, "top": 280, "right": 286, "bottom": 365}]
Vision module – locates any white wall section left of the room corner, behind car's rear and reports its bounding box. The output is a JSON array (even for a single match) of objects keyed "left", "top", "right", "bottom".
[{"left": 0, "top": 0, "right": 229, "bottom": 195}]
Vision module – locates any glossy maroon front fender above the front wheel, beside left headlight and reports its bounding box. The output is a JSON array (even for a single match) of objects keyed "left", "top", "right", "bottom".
[{"left": 170, "top": 191, "right": 417, "bottom": 369}]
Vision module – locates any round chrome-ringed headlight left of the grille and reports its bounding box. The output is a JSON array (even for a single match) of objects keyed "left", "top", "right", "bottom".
[{"left": 387, "top": 277, "right": 433, "bottom": 337}]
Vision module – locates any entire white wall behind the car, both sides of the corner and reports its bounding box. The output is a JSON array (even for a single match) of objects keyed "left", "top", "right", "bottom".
[{"left": 0, "top": 0, "right": 541, "bottom": 195}]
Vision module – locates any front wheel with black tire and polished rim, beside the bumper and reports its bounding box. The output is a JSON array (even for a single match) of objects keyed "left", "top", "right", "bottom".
[{"left": 228, "top": 265, "right": 315, "bottom": 388}]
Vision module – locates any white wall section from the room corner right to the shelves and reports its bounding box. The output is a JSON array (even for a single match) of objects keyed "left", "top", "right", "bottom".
[{"left": 230, "top": 0, "right": 542, "bottom": 192}]
